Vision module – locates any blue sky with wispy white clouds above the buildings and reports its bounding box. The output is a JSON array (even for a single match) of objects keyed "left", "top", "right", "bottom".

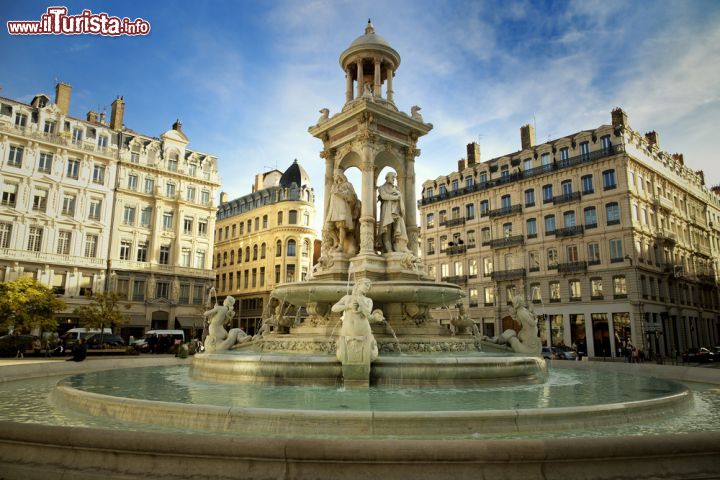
[{"left": 0, "top": 0, "right": 720, "bottom": 229}]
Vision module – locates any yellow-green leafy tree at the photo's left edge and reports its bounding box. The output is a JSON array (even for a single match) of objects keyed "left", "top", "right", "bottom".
[{"left": 0, "top": 277, "right": 66, "bottom": 333}]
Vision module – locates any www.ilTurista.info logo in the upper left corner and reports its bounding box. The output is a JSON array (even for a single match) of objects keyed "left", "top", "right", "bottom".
[{"left": 7, "top": 7, "right": 150, "bottom": 37}]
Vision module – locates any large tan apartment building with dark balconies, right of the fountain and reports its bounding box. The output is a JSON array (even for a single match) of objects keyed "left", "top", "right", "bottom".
[{"left": 418, "top": 109, "right": 720, "bottom": 357}]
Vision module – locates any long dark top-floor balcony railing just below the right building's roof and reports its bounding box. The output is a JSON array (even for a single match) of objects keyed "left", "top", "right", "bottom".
[{"left": 418, "top": 144, "right": 625, "bottom": 206}]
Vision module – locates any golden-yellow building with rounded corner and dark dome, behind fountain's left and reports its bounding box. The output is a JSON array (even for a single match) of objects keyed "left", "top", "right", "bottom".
[{"left": 215, "top": 160, "right": 317, "bottom": 334}]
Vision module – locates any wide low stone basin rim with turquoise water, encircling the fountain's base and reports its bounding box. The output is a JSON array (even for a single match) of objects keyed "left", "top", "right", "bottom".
[{"left": 53, "top": 364, "right": 692, "bottom": 438}]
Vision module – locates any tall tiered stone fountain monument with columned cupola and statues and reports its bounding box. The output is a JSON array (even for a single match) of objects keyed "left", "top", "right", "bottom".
[{"left": 192, "top": 18, "right": 546, "bottom": 387}]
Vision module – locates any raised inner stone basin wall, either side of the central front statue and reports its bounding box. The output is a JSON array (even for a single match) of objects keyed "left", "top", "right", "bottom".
[{"left": 191, "top": 351, "right": 547, "bottom": 386}]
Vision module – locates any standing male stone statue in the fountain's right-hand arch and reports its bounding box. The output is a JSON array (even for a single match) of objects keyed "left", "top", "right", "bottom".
[{"left": 378, "top": 172, "right": 408, "bottom": 253}]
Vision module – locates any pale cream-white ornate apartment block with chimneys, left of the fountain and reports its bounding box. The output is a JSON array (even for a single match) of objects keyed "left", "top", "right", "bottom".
[{"left": 0, "top": 83, "right": 219, "bottom": 335}]
